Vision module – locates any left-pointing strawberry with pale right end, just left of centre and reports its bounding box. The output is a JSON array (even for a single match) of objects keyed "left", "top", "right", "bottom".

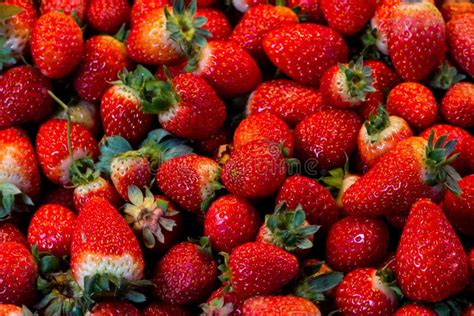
[{"left": 156, "top": 155, "right": 222, "bottom": 213}]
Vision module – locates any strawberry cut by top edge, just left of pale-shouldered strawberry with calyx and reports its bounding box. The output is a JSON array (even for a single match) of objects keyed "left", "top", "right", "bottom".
[{"left": 87, "top": 0, "right": 130, "bottom": 34}]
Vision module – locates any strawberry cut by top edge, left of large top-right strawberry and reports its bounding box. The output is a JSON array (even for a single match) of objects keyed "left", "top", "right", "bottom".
[{"left": 320, "top": 0, "right": 376, "bottom": 35}]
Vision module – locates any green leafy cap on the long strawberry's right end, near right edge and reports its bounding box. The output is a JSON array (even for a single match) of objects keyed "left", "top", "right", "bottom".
[{"left": 425, "top": 130, "right": 461, "bottom": 196}]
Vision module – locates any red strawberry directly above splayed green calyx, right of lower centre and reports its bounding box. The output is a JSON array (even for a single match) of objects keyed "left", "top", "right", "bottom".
[{"left": 276, "top": 175, "right": 339, "bottom": 232}]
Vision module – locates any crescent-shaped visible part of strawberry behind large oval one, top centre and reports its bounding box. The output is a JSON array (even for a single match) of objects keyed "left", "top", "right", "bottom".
[{"left": 229, "top": 4, "right": 299, "bottom": 62}]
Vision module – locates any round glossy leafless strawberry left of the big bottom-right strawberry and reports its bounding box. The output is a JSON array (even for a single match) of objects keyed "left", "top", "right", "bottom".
[{"left": 326, "top": 216, "right": 389, "bottom": 273}]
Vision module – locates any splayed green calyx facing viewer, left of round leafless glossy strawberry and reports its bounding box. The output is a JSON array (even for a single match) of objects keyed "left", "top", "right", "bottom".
[{"left": 265, "top": 202, "right": 319, "bottom": 252}]
